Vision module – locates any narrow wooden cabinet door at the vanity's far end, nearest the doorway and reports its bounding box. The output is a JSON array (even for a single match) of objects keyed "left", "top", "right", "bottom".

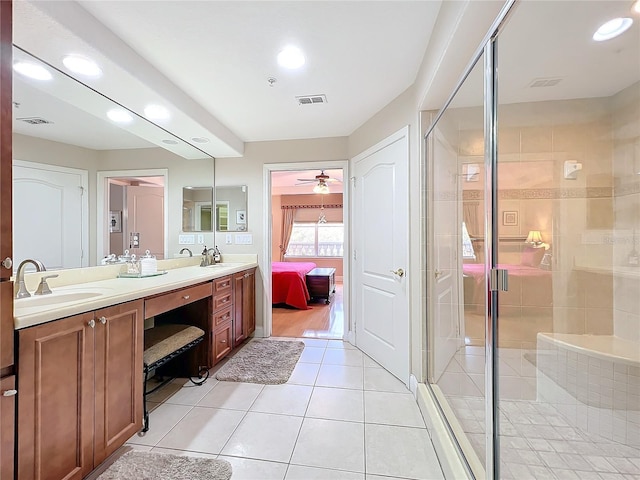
[{"left": 233, "top": 268, "right": 256, "bottom": 347}]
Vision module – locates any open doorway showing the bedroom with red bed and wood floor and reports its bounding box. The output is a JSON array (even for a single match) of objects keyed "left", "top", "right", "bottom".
[{"left": 265, "top": 162, "right": 349, "bottom": 340}]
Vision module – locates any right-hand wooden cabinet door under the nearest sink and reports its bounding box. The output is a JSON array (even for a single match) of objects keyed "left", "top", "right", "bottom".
[{"left": 94, "top": 300, "right": 144, "bottom": 465}]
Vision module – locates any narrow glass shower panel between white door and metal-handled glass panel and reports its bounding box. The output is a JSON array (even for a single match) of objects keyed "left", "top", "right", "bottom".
[{"left": 427, "top": 51, "right": 487, "bottom": 472}]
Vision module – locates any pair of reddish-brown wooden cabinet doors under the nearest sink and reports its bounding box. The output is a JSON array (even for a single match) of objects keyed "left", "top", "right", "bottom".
[{"left": 18, "top": 300, "right": 143, "bottom": 480}]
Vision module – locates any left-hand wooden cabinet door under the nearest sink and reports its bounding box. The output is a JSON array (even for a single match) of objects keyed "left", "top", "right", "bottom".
[{"left": 17, "top": 313, "right": 94, "bottom": 480}]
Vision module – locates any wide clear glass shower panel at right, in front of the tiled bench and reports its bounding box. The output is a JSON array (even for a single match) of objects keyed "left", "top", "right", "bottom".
[{"left": 496, "top": 1, "right": 640, "bottom": 479}]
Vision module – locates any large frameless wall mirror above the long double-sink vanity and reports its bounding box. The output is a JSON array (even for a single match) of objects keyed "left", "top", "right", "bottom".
[{"left": 13, "top": 46, "right": 214, "bottom": 270}]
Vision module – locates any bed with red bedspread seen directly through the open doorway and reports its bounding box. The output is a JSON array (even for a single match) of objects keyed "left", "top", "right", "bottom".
[{"left": 271, "top": 262, "right": 316, "bottom": 310}]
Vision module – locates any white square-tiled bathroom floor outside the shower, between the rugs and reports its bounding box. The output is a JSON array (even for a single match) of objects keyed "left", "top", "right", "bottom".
[{"left": 128, "top": 339, "right": 444, "bottom": 480}]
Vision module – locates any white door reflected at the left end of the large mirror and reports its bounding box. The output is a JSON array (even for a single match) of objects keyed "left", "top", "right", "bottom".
[{"left": 13, "top": 160, "right": 89, "bottom": 270}]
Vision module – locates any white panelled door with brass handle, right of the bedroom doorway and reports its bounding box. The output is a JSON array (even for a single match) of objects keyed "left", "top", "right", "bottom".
[{"left": 353, "top": 127, "right": 408, "bottom": 384}]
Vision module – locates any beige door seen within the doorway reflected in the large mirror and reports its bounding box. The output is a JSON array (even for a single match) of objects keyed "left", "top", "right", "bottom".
[{"left": 125, "top": 186, "right": 164, "bottom": 260}]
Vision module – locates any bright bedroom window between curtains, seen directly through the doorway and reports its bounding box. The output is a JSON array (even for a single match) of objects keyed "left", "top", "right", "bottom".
[{"left": 286, "top": 222, "right": 344, "bottom": 257}]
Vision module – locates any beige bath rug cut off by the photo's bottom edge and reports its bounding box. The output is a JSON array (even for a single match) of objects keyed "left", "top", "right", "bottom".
[{"left": 97, "top": 450, "right": 231, "bottom": 480}]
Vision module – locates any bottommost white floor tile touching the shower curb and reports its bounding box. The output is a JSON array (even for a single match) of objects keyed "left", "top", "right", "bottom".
[{"left": 365, "top": 424, "right": 444, "bottom": 480}]
